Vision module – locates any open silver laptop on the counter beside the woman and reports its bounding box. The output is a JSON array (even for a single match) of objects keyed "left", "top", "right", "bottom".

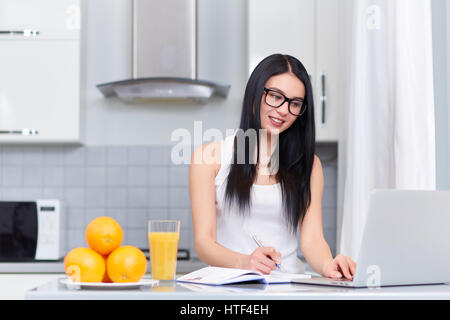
[{"left": 293, "top": 190, "right": 450, "bottom": 288}]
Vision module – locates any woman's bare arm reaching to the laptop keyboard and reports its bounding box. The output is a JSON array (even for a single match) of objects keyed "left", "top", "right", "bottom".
[{"left": 300, "top": 155, "right": 356, "bottom": 279}]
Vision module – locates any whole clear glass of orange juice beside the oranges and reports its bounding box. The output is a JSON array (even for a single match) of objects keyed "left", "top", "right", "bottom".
[{"left": 148, "top": 220, "right": 180, "bottom": 280}]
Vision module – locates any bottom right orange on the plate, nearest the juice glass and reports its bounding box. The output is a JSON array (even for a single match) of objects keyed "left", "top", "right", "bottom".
[{"left": 106, "top": 246, "right": 147, "bottom": 282}]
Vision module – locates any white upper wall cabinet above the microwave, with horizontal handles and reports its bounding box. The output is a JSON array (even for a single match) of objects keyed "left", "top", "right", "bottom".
[{"left": 0, "top": 0, "right": 81, "bottom": 143}]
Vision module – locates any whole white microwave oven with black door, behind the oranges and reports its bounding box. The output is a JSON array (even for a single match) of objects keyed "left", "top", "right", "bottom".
[{"left": 0, "top": 200, "right": 64, "bottom": 262}]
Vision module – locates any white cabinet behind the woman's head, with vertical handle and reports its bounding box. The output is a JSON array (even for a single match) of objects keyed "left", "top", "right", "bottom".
[{"left": 247, "top": 0, "right": 339, "bottom": 142}]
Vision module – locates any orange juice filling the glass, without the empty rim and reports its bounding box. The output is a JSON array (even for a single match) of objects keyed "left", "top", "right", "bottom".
[{"left": 148, "top": 232, "right": 180, "bottom": 280}]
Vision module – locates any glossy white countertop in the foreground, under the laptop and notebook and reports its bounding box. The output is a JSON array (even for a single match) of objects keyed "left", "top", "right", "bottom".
[{"left": 25, "top": 279, "right": 450, "bottom": 300}]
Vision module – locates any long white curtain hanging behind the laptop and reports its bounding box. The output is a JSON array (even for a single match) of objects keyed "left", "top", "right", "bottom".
[{"left": 337, "top": 0, "right": 435, "bottom": 260}]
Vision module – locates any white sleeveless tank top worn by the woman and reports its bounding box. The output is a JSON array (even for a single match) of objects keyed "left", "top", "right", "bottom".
[{"left": 214, "top": 130, "right": 305, "bottom": 273}]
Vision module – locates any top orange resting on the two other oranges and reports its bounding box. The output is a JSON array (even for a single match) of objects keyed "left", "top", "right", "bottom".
[{"left": 85, "top": 217, "right": 123, "bottom": 256}]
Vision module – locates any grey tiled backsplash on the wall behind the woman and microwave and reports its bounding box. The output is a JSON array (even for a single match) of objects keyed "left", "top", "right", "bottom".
[{"left": 0, "top": 145, "right": 337, "bottom": 255}]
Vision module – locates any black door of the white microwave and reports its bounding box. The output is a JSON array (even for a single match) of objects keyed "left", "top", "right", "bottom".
[{"left": 0, "top": 201, "right": 38, "bottom": 261}]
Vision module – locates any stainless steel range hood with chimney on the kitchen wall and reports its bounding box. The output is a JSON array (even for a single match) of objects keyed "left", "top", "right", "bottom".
[{"left": 97, "top": 0, "right": 230, "bottom": 102}]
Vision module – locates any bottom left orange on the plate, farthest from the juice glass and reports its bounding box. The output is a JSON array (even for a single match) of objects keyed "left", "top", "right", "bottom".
[{"left": 64, "top": 247, "right": 106, "bottom": 282}]
